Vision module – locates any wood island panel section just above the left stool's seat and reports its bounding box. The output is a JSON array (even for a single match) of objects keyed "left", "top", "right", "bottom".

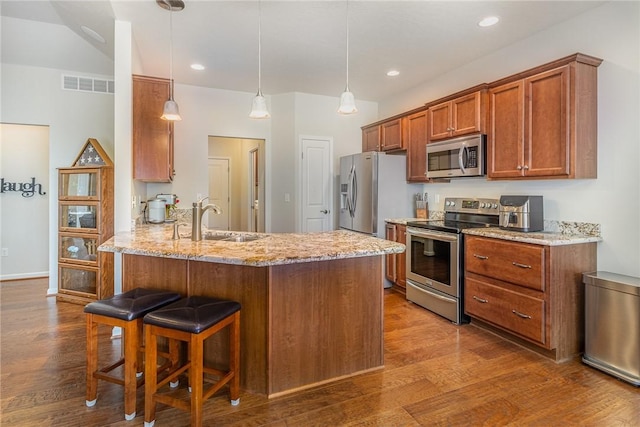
[{"left": 122, "top": 254, "right": 187, "bottom": 296}]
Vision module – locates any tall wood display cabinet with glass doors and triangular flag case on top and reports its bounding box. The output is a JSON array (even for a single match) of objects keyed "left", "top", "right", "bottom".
[{"left": 57, "top": 139, "right": 114, "bottom": 304}]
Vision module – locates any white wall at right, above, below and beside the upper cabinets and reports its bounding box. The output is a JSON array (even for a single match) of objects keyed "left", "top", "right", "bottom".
[{"left": 380, "top": 2, "right": 640, "bottom": 276}]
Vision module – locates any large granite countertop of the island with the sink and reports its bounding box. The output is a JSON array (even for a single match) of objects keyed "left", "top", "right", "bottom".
[{"left": 98, "top": 224, "right": 405, "bottom": 266}]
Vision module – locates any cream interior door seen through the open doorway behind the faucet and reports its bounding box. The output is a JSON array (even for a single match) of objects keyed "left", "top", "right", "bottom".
[{"left": 206, "top": 157, "right": 231, "bottom": 230}]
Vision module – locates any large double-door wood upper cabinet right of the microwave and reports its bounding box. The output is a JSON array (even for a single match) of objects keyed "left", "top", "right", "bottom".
[{"left": 487, "top": 54, "right": 602, "bottom": 179}]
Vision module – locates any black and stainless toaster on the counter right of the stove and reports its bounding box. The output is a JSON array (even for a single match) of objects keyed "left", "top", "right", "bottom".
[{"left": 499, "top": 196, "right": 544, "bottom": 232}]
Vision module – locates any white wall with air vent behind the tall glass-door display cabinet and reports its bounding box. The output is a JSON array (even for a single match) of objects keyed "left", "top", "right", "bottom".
[{"left": 0, "top": 63, "right": 114, "bottom": 293}]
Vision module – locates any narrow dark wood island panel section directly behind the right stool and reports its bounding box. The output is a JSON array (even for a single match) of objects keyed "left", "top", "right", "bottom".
[{"left": 188, "top": 261, "right": 268, "bottom": 394}]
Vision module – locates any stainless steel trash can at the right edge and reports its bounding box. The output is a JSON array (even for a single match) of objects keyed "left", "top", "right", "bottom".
[{"left": 582, "top": 271, "right": 640, "bottom": 386}]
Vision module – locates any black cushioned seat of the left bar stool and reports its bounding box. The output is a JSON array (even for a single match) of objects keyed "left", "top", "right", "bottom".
[{"left": 84, "top": 288, "right": 180, "bottom": 321}]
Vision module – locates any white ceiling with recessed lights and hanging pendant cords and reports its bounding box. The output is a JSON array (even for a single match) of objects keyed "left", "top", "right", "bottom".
[{"left": 0, "top": 0, "right": 603, "bottom": 101}]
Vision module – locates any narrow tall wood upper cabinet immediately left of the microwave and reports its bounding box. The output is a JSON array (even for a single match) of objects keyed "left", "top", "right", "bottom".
[{"left": 404, "top": 109, "right": 429, "bottom": 182}]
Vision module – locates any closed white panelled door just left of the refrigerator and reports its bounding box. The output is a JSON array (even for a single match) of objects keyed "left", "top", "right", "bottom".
[{"left": 299, "top": 137, "right": 333, "bottom": 232}]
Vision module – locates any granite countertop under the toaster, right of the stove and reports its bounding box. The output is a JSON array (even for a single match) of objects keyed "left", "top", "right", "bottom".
[{"left": 462, "top": 227, "right": 602, "bottom": 246}]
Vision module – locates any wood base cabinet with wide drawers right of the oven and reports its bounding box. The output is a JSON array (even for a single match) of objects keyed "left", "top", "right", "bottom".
[{"left": 464, "top": 235, "right": 596, "bottom": 361}]
